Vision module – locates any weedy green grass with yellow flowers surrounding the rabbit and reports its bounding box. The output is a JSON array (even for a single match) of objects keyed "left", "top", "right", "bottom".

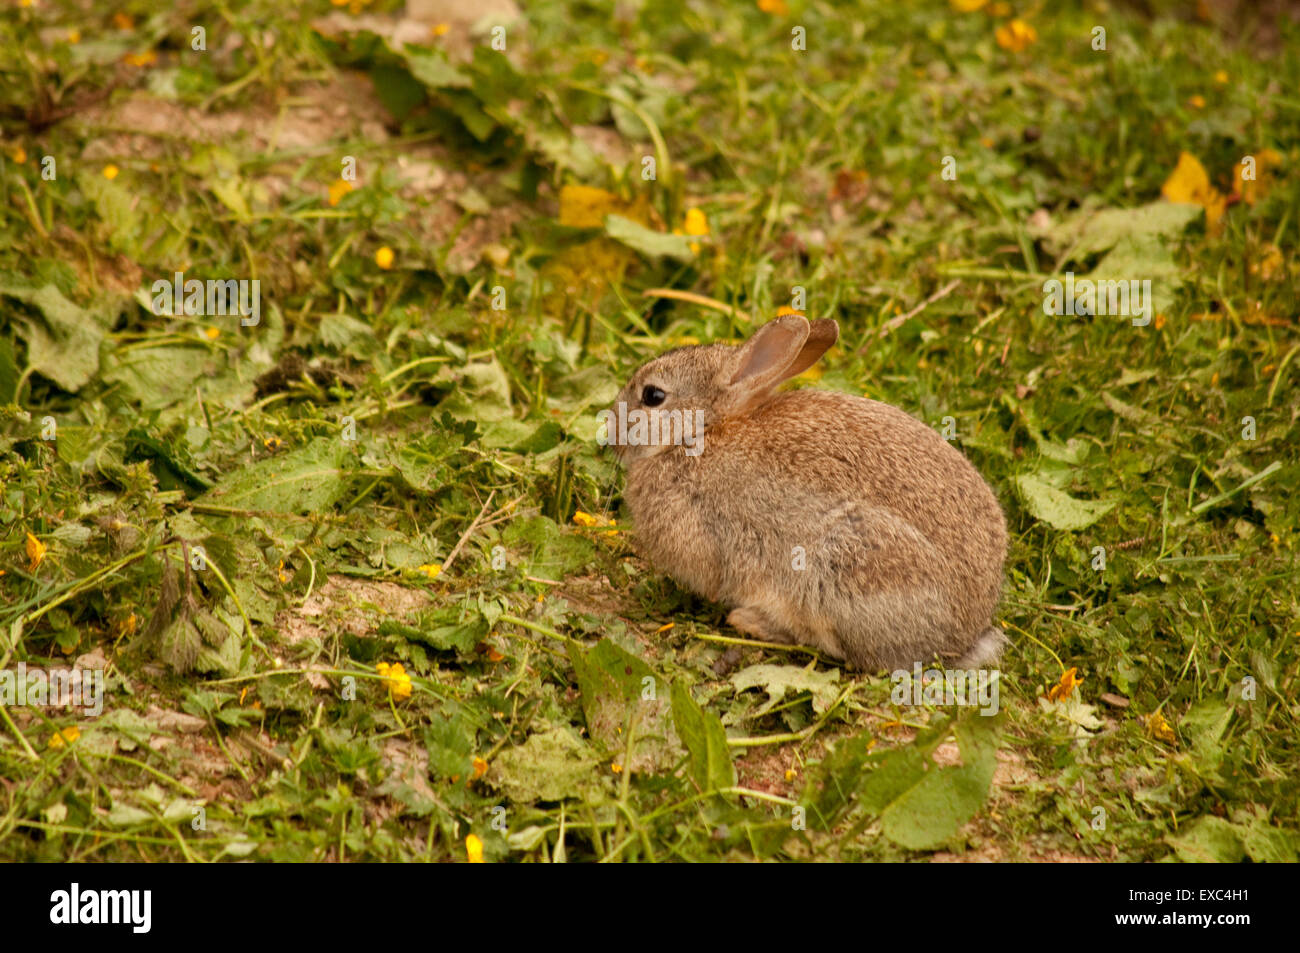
[{"left": 0, "top": 1, "right": 1300, "bottom": 861}]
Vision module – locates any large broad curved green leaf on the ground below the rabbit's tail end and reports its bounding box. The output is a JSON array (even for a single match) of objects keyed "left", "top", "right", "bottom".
[{"left": 862, "top": 714, "right": 1001, "bottom": 850}]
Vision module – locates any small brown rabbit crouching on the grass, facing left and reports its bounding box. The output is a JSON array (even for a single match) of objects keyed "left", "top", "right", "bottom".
[{"left": 602, "top": 315, "right": 1006, "bottom": 671}]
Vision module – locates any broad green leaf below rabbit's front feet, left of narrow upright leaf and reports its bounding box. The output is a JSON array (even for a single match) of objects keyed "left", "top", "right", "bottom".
[{"left": 568, "top": 638, "right": 685, "bottom": 772}]
